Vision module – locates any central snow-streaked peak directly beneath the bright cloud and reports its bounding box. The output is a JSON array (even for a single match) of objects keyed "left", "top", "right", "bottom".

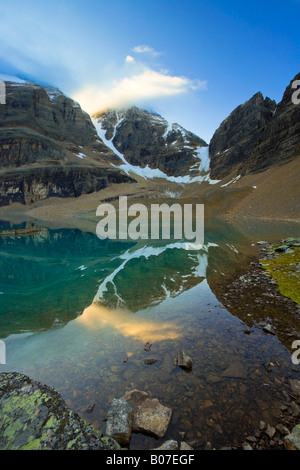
[{"left": 94, "top": 106, "right": 208, "bottom": 176}]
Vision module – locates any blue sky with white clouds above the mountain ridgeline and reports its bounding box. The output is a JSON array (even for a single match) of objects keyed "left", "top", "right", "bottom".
[{"left": 0, "top": 0, "right": 300, "bottom": 142}]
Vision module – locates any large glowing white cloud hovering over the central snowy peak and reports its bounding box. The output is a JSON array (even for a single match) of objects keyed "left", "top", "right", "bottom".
[{"left": 73, "top": 66, "right": 206, "bottom": 114}]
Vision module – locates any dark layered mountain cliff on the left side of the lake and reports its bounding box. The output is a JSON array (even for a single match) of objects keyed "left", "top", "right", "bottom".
[{"left": 0, "top": 82, "right": 131, "bottom": 206}]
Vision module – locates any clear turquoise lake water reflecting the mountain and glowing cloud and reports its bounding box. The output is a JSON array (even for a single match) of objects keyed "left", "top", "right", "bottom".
[{"left": 0, "top": 218, "right": 300, "bottom": 449}]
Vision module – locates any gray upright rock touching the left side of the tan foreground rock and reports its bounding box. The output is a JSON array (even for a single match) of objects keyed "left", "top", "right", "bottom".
[{"left": 106, "top": 398, "right": 133, "bottom": 446}]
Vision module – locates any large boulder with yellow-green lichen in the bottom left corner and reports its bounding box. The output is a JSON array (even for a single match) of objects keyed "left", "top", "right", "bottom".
[{"left": 0, "top": 372, "right": 120, "bottom": 450}]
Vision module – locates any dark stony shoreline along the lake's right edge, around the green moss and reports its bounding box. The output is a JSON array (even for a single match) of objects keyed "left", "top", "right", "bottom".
[{"left": 213, "top": 238, "right": 300, "bottom": 450}]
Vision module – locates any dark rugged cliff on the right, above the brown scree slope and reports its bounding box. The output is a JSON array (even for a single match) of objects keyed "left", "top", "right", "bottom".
[{"left": 209, "top": 74, "right": 300, "bottom": 178}]
